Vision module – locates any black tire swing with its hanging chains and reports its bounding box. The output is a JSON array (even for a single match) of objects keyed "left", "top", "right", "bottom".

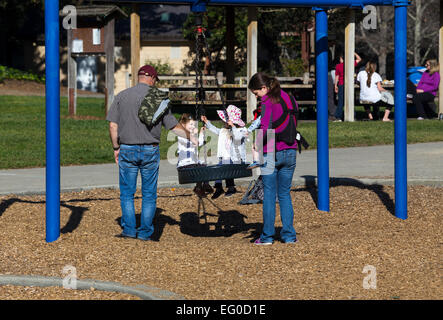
[{"left": 177, "top": 15, "right": 252, "bottom": 184}]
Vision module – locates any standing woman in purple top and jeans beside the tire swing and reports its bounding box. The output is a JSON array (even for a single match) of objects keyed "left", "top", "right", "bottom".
[{"left": 248, "top": 73, "right": 297, "bottom": 245}]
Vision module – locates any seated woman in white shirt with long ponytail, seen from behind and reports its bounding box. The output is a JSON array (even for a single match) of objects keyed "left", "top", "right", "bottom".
[{"left": 357, "top": 61, "right": 394, "bottom": 122}]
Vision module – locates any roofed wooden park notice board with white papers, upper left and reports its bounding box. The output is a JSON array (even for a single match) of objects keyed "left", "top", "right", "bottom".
[{"left": 59, "top": 5, "right": 127, "bottom": 116}]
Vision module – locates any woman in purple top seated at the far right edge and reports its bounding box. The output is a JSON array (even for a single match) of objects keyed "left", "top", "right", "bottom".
[{"left": 412, "top": 59, "right": 440, "bottom": 120}]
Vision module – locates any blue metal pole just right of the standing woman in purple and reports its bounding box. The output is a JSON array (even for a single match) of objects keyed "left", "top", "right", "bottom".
[{"left": 314, "top": 8, "right": 329, "bottom": 212}]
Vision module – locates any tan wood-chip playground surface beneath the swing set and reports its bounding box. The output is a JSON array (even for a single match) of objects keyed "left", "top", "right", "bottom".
[{"left": 0, "top": 186, "right": 443, "bottom": 300}]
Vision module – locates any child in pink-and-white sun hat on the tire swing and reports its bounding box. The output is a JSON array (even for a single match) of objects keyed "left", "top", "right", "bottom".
[{"left": 201, "top": 105, "right": 248, "bottom": 199}]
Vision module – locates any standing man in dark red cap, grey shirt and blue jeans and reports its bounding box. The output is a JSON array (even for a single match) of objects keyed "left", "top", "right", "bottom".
[{"left": 106, "top": 65, "right": 191, "bottom": 240}]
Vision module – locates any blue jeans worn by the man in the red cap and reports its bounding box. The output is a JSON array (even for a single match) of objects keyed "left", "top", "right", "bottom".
[{"left": 118, "top": 144, "right": 160, "bottom": 240}]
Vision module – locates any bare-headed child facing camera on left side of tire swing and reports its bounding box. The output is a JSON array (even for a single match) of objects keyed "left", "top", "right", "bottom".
[{"left": 177, "top": 113, "right": 214, "bottom": 198}]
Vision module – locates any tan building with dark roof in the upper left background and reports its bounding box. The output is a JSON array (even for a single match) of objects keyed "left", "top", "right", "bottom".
[{"left": 20, "top": 4, "right": 191, "bottom": 94}]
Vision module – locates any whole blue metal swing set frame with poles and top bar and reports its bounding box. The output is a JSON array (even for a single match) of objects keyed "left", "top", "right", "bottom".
[{"left": 45, "top": 0, "right": 410, "bottom": 242}]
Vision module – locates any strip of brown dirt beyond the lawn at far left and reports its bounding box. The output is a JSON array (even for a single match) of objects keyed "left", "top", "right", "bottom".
[{"left": 0, "top": 79, "right": 101, "bottom": 96}]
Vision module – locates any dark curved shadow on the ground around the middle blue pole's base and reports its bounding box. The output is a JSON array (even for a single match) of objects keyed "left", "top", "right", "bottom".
[{"left": 292, "top": 176, "right": 395, "bottom": 216}]
